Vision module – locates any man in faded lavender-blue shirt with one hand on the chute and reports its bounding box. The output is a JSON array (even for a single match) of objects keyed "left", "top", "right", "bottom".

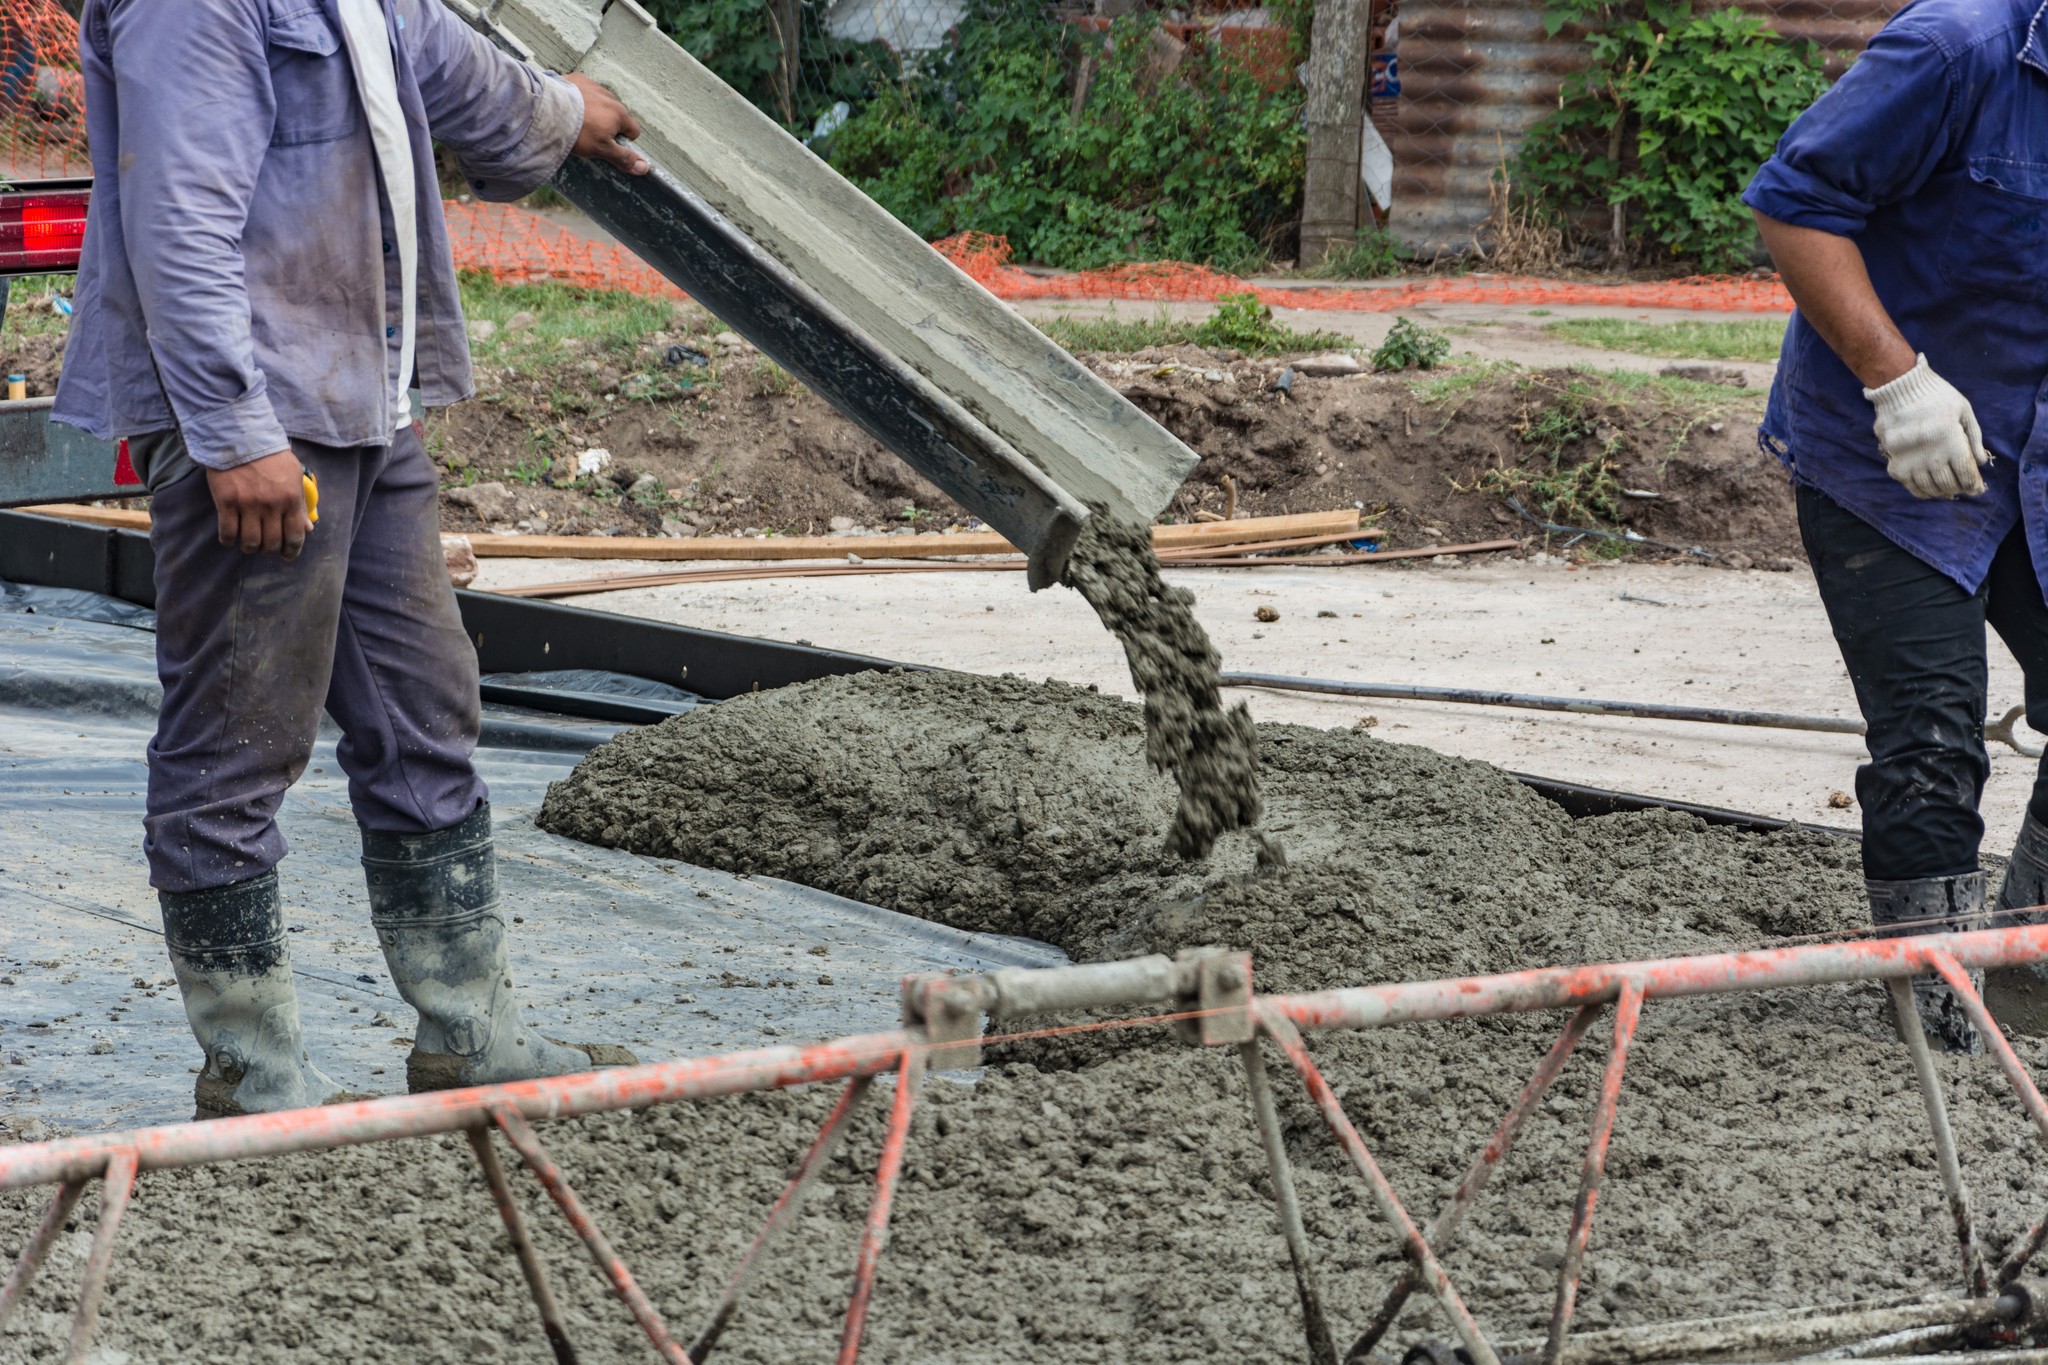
[{"left": 53, "top": 0, "right": 647, "bottom": 1115}]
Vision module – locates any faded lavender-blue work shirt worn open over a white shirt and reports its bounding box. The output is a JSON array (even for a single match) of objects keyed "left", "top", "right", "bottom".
[{"left": 51, "top": 0, "right": 584, "bottom": 469}]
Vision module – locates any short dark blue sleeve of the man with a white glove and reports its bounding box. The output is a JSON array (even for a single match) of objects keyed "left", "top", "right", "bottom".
[{"left": 1743, "top": 23, "right": 1956, "bottom": 237}]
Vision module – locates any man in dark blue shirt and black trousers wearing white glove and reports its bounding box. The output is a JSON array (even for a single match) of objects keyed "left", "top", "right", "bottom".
[{"left": 1743, "top": 0, "right": 2048, "bottom": 1052}]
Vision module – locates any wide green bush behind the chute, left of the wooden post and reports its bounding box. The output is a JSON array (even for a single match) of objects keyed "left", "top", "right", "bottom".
[{"left": 825, "top": 8, "right": 1305, "bottom": 270}]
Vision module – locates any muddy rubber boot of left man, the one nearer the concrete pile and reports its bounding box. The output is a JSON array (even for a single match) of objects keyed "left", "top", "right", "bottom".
[{"left": 362, "top": 804, "right": 635, "bottom": 1095}]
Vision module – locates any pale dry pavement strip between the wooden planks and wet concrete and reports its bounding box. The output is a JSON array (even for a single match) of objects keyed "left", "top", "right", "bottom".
[{"left": 477, "top": 559, "right": 2034, "bottom": 853}]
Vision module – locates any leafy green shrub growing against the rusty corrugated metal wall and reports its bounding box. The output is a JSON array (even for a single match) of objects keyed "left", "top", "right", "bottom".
[{"left": 1518, "top": 0, "right": 1827, "bottom": 270}]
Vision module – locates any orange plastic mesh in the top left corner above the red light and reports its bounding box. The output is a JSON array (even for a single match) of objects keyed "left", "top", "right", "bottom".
[{"left": 0, "top": 0, "right": 92, "bottom": 180}]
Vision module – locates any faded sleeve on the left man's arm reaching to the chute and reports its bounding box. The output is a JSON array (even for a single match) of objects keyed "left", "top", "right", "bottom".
[{"left": 397, "top": 0, "right": 584, "bottom": 201}]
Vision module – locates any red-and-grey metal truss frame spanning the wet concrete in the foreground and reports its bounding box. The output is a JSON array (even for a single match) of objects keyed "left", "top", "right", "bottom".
[{"left": 0, "top": 925, "right": 2048, "bottom": 1365}]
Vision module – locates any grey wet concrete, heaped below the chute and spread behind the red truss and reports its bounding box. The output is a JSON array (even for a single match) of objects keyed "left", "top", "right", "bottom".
[{"left": 0, "top": 673, "right": 2048, "bottom": 1363}]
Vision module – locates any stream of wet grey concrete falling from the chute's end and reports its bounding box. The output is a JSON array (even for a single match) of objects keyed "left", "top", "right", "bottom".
[{"left": 1065, "top": 510, "right": 1260, "bottom": 857}]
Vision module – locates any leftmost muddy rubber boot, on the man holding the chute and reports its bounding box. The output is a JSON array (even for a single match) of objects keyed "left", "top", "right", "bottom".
[{"left": 158, "top": 872, "right": 342, "bottom": 1119}]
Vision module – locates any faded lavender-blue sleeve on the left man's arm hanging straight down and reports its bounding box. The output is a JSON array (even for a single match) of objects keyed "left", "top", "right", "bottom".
[{"left": 111, "top": 0, "right": 289, "bottom": 469}]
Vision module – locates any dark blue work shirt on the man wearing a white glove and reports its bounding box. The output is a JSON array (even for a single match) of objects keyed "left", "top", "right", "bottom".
[{"left": 1743, "top": 0, "right": 2048, "bottom": 591}]
